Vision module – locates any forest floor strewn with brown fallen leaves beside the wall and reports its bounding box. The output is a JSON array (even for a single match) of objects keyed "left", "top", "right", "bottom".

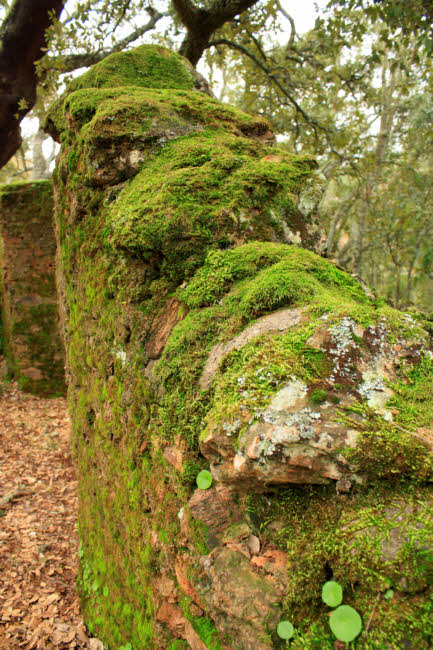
[{"left": 0, "top": 384, "right": 95, "bottom": 650}]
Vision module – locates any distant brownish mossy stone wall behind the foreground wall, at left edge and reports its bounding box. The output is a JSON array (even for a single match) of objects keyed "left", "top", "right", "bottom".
[{"left": 0, "top": 181, "right": 65, "bottom": 395}]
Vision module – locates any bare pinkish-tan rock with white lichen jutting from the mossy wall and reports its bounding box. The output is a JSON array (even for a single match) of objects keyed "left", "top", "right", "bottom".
[{"left": 200, "top": 309, "right": 427, "bottom": 491}]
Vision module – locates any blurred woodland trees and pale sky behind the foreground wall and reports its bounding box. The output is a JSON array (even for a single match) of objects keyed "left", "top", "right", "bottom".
[{"left": 1, "top": 0, "right": 433, "bottom": 309}]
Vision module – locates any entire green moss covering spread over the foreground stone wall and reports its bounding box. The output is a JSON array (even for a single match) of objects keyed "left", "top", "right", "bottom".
[{"left": 49, "top": 43, "right": 430, "bottom": 650}]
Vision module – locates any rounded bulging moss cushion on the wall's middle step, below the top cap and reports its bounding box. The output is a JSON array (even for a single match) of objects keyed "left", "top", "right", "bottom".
[{"left": 106, "top": 129, "right": 311, "bottom": 282}]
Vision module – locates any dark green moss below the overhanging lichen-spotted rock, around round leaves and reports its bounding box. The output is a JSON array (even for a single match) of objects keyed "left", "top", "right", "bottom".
[{"left": 248, "top": 485, "right": 433, "bottom": 650}]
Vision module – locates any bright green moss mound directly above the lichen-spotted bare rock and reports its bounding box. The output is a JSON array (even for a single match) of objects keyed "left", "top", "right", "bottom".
[{"left": 156, "top": 242, "right": 428, "bottom": 454}]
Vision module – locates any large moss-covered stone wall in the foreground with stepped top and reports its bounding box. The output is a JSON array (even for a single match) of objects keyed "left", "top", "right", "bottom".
[{"left": 47, "top": 46, "right": 433, "bottom": 650}]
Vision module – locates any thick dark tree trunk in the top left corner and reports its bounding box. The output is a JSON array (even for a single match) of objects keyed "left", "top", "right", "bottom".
[{"left": 0, "top": 0, "right": 64, "bottom": 167}]
